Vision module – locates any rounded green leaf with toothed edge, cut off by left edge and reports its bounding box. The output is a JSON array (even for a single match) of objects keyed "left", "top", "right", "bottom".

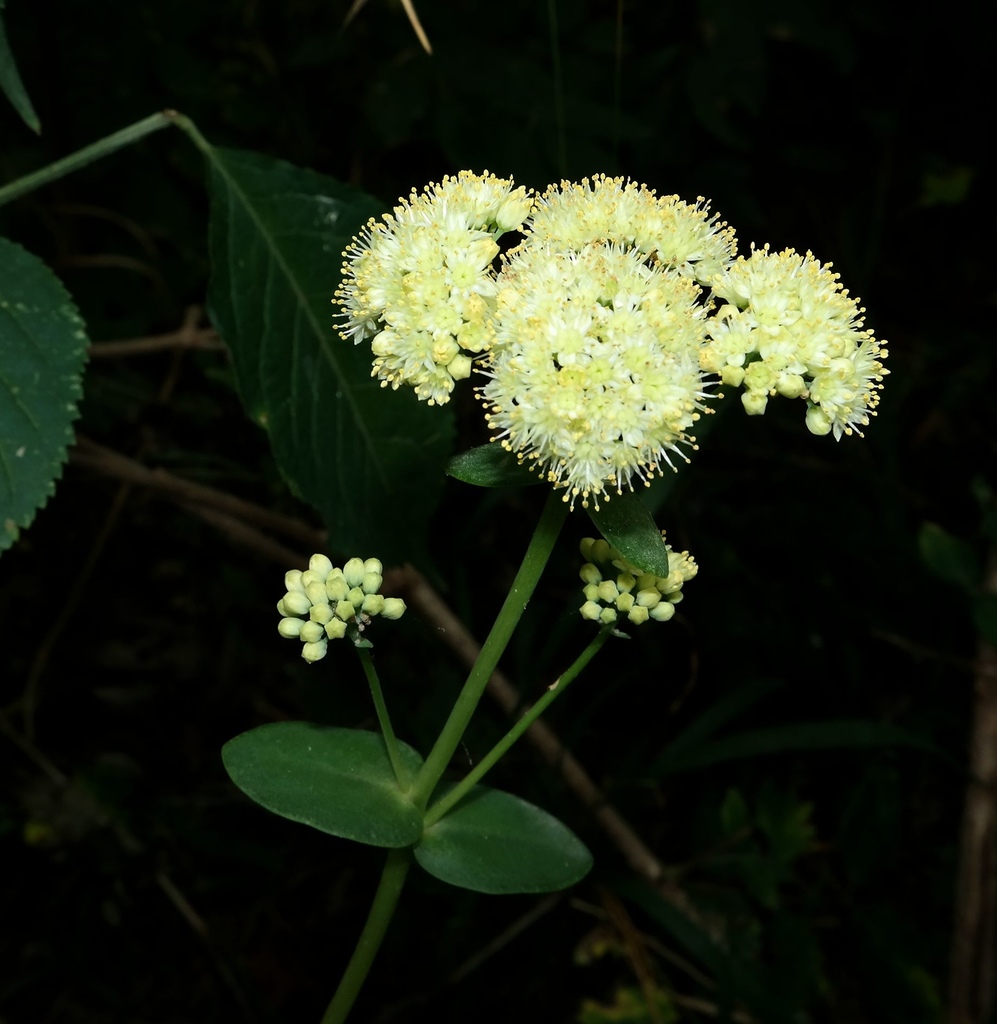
[{"left": 0, "top": 239, "right": 88, "bottom": 551}]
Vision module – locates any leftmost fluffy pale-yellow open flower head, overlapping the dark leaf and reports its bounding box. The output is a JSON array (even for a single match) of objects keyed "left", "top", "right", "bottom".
[{"left": 336, "top": 171, "right": 533, "bottom": 406}]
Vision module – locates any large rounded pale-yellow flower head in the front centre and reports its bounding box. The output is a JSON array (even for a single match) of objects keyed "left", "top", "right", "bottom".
[{"left": 480, "top": 243, "right": 706, "bottom": 508}]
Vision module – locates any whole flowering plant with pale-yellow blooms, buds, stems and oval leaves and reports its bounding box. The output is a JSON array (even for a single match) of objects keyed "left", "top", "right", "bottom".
[{"left": 223, "top": 171, "right": 886, "bottom": 1024}]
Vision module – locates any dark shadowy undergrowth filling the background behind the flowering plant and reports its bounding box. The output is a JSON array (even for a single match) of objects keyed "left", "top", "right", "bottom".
[{"left": 0, "top": 0, "right": 997, "bottom": 1024}]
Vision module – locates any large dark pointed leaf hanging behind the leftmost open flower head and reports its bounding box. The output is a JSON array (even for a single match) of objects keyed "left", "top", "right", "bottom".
[{"left": 195, "top": 142, "right": 452, "bottom": 562}]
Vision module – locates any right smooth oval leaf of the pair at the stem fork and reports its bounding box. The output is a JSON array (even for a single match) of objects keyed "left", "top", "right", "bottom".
[{"left": 416, "top": 785, "right": 592, "bottom": 893}]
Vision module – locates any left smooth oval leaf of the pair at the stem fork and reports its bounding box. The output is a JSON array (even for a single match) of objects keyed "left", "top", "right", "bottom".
[{"left": 221, "top": 722, "right": 423, "bottom": 848}]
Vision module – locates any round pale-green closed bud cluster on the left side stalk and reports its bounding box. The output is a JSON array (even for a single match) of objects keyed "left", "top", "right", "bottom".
[{"left": 277, "top": 555, "right": 405, "bottom": 662}]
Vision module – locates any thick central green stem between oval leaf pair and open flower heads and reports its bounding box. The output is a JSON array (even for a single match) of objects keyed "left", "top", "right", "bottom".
[{"left": 410, "top": 490, "right": 568, "bottom": 808}]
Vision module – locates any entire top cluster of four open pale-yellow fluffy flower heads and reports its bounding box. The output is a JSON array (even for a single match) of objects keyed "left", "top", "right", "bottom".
[{"left": 336, "top": 171, "right": 887, "bottom": 508}]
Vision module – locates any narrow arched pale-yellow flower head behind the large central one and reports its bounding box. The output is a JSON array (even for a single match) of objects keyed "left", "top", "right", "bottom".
[{"left": 525, "top": 174, "right": 737, "bottom": 285}]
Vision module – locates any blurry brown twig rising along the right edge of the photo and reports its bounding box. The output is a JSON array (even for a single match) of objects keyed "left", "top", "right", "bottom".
[{"left": 947, "top": 550, "right": 997, "bottom": 1024}]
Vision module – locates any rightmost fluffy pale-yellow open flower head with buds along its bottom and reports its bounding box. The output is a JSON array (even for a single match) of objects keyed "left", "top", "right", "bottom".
[{"left": 700, "top": 246, "right": 890, "bottom": 438}]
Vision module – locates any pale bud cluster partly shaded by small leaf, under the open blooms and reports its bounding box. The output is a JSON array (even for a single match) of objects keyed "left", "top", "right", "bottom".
[{"left": 579, "top": 531, "right": 699, "bottom": 626}]
